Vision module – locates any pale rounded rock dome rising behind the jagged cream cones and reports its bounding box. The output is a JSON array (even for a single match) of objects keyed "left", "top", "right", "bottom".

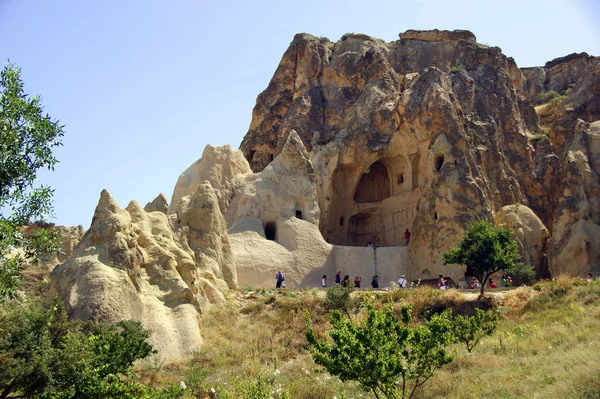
[{"left": 169, "top": 145, "right": 252, "bottom": 213}]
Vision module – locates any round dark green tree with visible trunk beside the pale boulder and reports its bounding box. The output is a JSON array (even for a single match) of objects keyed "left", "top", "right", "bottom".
[{"left": 443, "top": 219, "right": 520, "bottom": 296}]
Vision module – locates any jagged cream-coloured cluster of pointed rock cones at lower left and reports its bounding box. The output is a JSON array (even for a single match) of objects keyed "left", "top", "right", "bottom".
[{"left": 50, "top": 188, "right": 236, "bottom": 360}]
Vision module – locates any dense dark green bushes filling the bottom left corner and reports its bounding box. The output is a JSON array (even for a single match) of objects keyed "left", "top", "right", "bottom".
[{"left": 0, "top": 301, "right": 177, "bottom": 398}]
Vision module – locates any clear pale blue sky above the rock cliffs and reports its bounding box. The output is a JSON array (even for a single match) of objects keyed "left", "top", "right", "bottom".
[{"left": 0, "top": 0, "right": 600, "bottom": 227}]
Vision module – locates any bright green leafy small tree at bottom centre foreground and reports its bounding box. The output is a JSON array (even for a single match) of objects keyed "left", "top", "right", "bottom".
[{"left": 306, "top": 304, "right": 453, "bottom": 399}]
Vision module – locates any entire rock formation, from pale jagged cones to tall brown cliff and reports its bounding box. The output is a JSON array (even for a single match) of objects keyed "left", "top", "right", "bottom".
[{"left": 51, "top": 30, "right": 600, "bottom": 364}]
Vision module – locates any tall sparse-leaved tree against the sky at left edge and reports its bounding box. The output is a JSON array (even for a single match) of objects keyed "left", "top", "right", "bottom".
[{"left": 0, "top": 62, "right": 64, "bottom": 301}]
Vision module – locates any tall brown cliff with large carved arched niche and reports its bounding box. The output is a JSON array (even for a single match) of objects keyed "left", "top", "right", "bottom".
[{"left": 241, "top": 31, "right": 597, "bottom": 278}]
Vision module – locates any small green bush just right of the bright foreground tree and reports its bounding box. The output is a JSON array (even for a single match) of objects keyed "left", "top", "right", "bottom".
[{"left": 453, "top": 309, "right": 498, "bottom": 352}]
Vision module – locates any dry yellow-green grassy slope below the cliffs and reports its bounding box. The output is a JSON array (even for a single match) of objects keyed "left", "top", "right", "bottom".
[{"left": 141, "top": 280, "right": 600, "bottom": 399}]
